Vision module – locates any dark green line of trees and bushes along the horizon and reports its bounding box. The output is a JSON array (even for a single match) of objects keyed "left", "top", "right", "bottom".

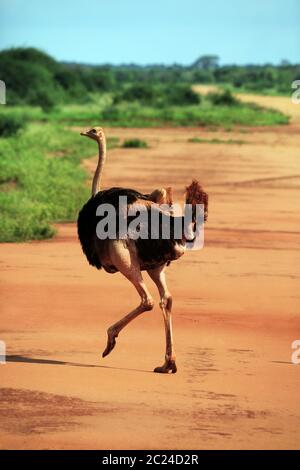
[{"left": 0, "top": 48, "right": 300, "bottom": 110}]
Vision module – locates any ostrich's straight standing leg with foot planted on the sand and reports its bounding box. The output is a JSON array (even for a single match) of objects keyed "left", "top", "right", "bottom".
[{"left": 148, "top": 266, "right": 177, "bottom": 374}]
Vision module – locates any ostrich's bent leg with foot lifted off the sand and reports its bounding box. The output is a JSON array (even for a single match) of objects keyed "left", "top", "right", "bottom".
[{"left": 102, "top": 243, "right": 154, "bottom": 357}]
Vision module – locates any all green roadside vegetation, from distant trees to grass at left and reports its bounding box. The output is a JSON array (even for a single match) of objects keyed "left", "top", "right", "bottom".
[{"left": 0, "top": 48, "right": 300, "bottom": 242}]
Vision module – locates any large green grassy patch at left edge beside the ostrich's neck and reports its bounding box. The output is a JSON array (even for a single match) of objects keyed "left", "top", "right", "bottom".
[{"left": 0, "top": 124, "right": 115, "bottom": 242}]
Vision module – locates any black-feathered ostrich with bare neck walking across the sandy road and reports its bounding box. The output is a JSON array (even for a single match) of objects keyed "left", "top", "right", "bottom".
[{"left": 77, "top": 127, "right": 208, "bottom": 373}]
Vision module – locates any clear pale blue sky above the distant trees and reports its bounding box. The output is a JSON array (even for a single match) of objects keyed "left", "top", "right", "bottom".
[{"left": 0, "top": 0, "right": 300, "bottom": 64}]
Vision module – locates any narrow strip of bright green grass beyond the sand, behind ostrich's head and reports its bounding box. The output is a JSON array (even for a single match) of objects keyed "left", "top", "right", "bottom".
[{"left": 3, "top": 94, "right": 289, "bottom": 131}]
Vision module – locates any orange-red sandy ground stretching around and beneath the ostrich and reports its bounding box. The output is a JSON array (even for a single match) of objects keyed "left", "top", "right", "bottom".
[{"left": 0, "top": 94, "right": 300, "bottom": 449}]
